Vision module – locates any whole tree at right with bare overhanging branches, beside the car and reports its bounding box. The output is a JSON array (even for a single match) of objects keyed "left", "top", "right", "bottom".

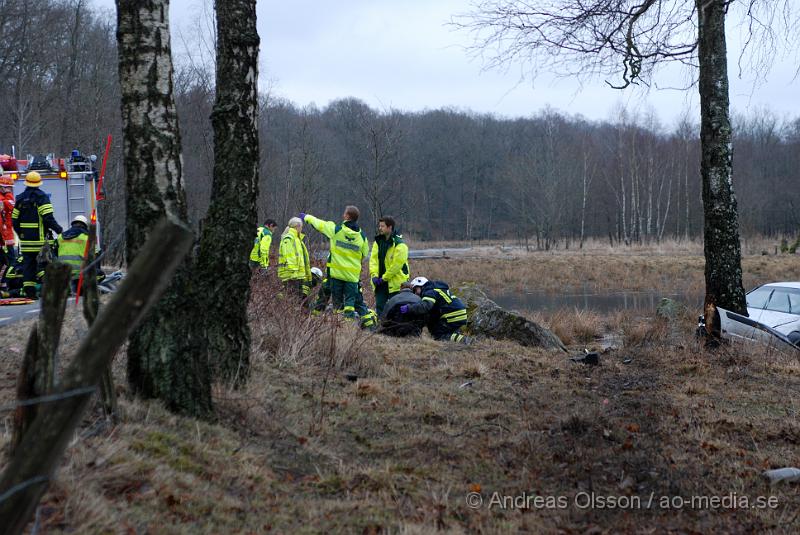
[{"left": 457, "top": 0, "right": 800, "bottom": 314}]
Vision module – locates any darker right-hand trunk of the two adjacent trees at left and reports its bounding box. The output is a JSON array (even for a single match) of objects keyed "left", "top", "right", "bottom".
[{"left": 192, "top": 0, "right": 259, "bottom": 384}]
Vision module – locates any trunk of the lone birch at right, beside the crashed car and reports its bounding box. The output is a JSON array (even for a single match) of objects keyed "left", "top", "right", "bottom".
[{"left": 696, "top": 0, "right": 747, "bottom": 315}]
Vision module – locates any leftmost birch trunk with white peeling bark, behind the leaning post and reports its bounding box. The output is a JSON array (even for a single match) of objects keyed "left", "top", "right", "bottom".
[{"left": 117, "top": 0, "right": 211, "bottom": 417}]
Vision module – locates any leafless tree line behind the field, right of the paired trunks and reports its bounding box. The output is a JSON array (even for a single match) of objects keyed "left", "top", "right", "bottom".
[{"left": 245, "top": 99, "right": 800, "bottom": 249}]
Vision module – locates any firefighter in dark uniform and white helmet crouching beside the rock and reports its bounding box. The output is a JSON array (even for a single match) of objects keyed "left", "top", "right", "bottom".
[{"left": 400, "top": 277, "right": 471, "bottom": 344}]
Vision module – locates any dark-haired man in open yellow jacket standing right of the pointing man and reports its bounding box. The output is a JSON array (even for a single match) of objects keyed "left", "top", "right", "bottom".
[{"left": 369, "top": 217, "right": 409, "bottom": 316}]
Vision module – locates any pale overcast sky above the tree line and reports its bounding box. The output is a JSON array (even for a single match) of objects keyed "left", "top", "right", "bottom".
[{"left": 94, "top": 0, "right": 800, "bottom": 125}]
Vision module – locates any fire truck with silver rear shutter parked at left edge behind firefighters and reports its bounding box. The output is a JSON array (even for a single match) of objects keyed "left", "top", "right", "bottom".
[{"left": 0, "top": 150, "right": 100, "bottom": 236}]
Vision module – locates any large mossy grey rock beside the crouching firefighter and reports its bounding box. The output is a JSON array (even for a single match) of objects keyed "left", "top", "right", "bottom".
[{"left": 455, "top": 285, "right": 567, "bottom": 351}]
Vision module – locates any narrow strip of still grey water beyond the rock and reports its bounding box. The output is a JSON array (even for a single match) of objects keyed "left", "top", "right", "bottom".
[{"left": 492, "top": 291, "right": 703, "bottom": 313}]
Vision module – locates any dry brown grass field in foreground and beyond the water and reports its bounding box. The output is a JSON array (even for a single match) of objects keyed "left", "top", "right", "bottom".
[{"left": 0, "top": 253, "right": 800, "bottom": 534}]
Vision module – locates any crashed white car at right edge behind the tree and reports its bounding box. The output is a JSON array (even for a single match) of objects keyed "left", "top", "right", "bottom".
[{"left": 698, "top": 282, "right": 800, "bottom": 348}]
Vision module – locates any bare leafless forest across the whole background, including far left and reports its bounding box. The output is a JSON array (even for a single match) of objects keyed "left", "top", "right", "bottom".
[{"left": 0, "top": 0, "right": 800, "bottom": 259}]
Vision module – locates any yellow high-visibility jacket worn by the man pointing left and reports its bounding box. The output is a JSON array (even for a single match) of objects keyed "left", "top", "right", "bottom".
[{"left": 305, "top": 214, "right": 369, "bottom": 282}]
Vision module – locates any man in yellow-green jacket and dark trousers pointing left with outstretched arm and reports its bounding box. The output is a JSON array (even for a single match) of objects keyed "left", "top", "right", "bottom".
[{"left": 300, "top": 206, "right": 369, "bottom": 318}]
